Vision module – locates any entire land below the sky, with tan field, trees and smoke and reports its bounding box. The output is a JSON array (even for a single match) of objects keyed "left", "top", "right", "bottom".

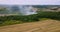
[{"left": 0, "top": 5, "right": 60, "bottom": 32}]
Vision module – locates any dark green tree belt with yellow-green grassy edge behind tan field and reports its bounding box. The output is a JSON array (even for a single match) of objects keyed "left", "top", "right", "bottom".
[{"left": 0, "top": 12, "right": 60, "bottom": 24}]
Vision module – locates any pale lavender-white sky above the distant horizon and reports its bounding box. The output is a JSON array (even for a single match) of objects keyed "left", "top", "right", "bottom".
[{"left": 0, "top": 0, "right": 60, "bottom": 5}]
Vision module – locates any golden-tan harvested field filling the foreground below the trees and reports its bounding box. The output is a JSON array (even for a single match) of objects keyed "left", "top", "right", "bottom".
[{"left": 0, "top": 20, "right": 60, "bottom": 32}]
